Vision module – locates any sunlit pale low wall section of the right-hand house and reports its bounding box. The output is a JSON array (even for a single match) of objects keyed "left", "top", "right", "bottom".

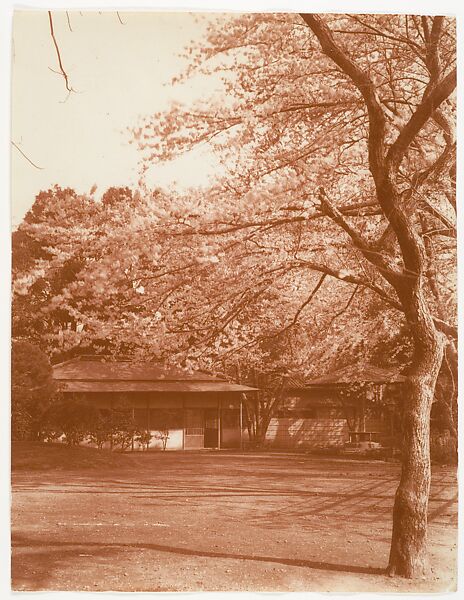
[{"left": 266, "top": 417, "right": 349, "bottom": 448}]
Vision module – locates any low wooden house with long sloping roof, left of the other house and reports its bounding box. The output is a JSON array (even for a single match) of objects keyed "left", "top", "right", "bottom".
[{"left": 53, "top": 356, "right": 254, "bottom": 450}]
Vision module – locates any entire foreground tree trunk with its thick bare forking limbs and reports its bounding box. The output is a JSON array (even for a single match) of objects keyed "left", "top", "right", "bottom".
[{"left": 301, "top": 14, "right": 456, "bottom": 577}]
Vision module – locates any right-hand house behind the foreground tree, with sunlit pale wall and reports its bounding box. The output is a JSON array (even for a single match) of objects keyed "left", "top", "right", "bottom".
[{"left": 266, "top": 363, "right": 405, "bottom": 448}]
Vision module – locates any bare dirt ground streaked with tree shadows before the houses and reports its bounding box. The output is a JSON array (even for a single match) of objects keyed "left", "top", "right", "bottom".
[{"left": 12, "top": 444, "right": 457, "bottom": 593}]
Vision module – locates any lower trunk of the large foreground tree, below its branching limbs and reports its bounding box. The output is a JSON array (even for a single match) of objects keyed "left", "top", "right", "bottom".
[{"left": 388, "top": 293, "right": 444, "bottom": 578}]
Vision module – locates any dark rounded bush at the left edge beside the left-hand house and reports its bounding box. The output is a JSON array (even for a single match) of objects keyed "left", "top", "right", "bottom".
[{"left": 11, "top": 340, "right": 55, "bottom": 440}]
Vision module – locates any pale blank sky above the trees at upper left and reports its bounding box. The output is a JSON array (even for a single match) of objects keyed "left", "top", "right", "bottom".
[{"left": 11, "top": 10, "right": 221, "bottom": 226}]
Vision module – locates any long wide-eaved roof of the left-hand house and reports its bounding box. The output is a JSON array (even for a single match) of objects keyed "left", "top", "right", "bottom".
[{"left": 53, "top": 356, "right": 255, "bottom": 393}]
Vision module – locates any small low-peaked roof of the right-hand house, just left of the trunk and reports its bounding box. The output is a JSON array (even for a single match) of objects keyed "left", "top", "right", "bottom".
[{"left": 306, "top": 363, "right": 406, "bottom": 387}]
